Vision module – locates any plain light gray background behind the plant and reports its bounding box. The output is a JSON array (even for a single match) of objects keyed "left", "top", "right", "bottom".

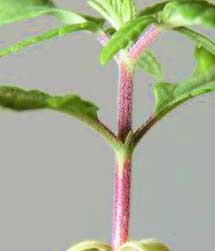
[{"left": 0, "top": 0, "right": 215, "bottom": 251}]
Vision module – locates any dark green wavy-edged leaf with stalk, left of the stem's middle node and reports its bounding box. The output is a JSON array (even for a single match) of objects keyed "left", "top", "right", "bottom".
[{"left": 0, "top": 86, "right": 122, "bottom": 148}]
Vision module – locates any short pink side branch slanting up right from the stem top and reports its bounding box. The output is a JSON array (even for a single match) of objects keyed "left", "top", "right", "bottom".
[{"left": 128, "top": 25, "right": 160, "bottom": 61}]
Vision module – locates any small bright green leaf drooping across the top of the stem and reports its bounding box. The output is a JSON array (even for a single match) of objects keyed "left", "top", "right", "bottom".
[{"left": 100, "top": 16, "right": 155, "bottom": 64}]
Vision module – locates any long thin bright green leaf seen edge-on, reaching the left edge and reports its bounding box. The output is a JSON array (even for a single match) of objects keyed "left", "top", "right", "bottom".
[{"left": 0, "top": 22, "right": 103, "bottom": 57}]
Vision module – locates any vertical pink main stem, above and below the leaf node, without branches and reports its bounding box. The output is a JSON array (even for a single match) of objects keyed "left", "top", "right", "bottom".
[{"left": 112, "top": 62, "right": 133, "bottom": 251}]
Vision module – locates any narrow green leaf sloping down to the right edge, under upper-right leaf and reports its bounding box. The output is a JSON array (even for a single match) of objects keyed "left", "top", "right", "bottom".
[{"left": 174, "top": 27, "right": 215, "bottom": 56}]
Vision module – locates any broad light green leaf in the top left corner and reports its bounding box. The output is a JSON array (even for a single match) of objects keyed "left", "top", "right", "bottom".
[{"left": 0, "top": 0, "right": 54, "bottom": 25}]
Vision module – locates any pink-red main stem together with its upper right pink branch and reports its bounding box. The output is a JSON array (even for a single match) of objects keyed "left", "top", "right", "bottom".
[{"left": 112, "top": 26, "right": 160, "bottom": 251}]
